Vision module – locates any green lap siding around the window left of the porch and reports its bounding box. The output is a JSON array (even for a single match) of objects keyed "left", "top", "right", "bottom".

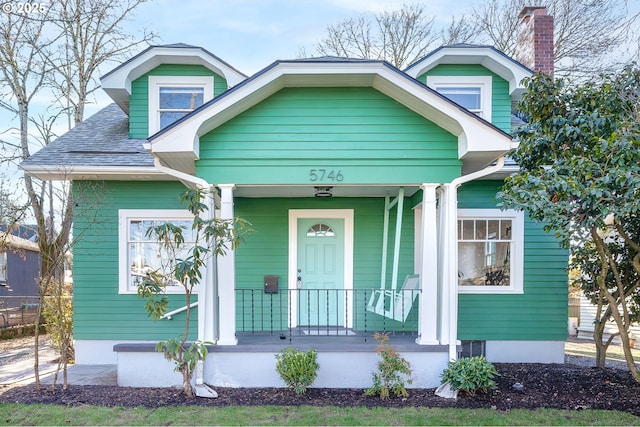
[{"left": 73, "top": 182, "right": 197, "bottom": 340}]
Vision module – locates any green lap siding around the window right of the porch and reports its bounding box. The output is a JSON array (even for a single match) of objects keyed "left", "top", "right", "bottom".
[{"left": 458, "top": 181, "right": 568, "bottom": 340}]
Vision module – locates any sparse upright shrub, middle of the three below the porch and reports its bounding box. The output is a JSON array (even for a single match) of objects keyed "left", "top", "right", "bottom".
[{"left": 365, "top": 333, "right": 412, "bottom": 400}]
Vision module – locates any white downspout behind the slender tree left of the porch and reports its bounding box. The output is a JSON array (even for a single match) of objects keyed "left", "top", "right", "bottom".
[{"left": 145, "top": 156, "right": 218, "bottom": 398}]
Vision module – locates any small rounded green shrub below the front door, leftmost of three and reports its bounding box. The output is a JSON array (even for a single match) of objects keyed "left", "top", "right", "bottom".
[{"left": 276, "top": 347, "right": 320, "bottom": 394}]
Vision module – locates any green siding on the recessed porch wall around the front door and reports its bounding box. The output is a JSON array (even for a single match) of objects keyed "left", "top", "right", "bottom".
[{"left": 234, "top": 198, "right": 417, "bottom": 331}]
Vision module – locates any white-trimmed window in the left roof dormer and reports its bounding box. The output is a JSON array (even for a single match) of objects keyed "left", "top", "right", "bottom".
[{"left": 149, "top": 76, "right": 213, "bottom": 135}]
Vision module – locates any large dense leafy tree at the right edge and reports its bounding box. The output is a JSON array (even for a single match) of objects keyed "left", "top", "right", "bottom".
[{"left": 499, "top": 67, "right": 640, "bottom": 381}]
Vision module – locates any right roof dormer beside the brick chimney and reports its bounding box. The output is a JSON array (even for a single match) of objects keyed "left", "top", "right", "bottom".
[{"left": 406, "top": 44, "right": 533, "bottom": 132}]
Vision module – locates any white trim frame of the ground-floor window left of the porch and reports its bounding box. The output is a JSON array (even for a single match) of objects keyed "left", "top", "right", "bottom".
[{"left": 118, "top": 209, "right": 198, "bottom": 294}]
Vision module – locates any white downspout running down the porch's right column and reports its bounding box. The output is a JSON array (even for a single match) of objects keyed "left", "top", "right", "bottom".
[{"left": 443, "top": 156, "right": 504, "bottom": 360}]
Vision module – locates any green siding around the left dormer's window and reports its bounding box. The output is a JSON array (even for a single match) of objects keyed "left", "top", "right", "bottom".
[{"left": 129, "top": 64, "right": 227, "bottom": 139}]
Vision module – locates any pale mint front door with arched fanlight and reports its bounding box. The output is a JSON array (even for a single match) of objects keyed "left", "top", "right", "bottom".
[{"left": 296, "top": 218, "right": 346, "bottom": 326}]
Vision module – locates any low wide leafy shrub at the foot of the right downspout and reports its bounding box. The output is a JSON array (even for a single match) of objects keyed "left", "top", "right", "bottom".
[{"left": 442, "top": 356, "right": 499, "bottom": 396}]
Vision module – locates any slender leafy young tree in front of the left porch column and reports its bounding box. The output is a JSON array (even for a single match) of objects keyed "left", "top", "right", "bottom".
[{"left": 138, "top": 190, "right": 248, "bottom": 397}]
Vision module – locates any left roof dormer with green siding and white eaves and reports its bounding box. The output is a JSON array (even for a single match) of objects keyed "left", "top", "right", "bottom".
[{"left": 101, "top": 43, "right": 246, "bottom": 138}]
